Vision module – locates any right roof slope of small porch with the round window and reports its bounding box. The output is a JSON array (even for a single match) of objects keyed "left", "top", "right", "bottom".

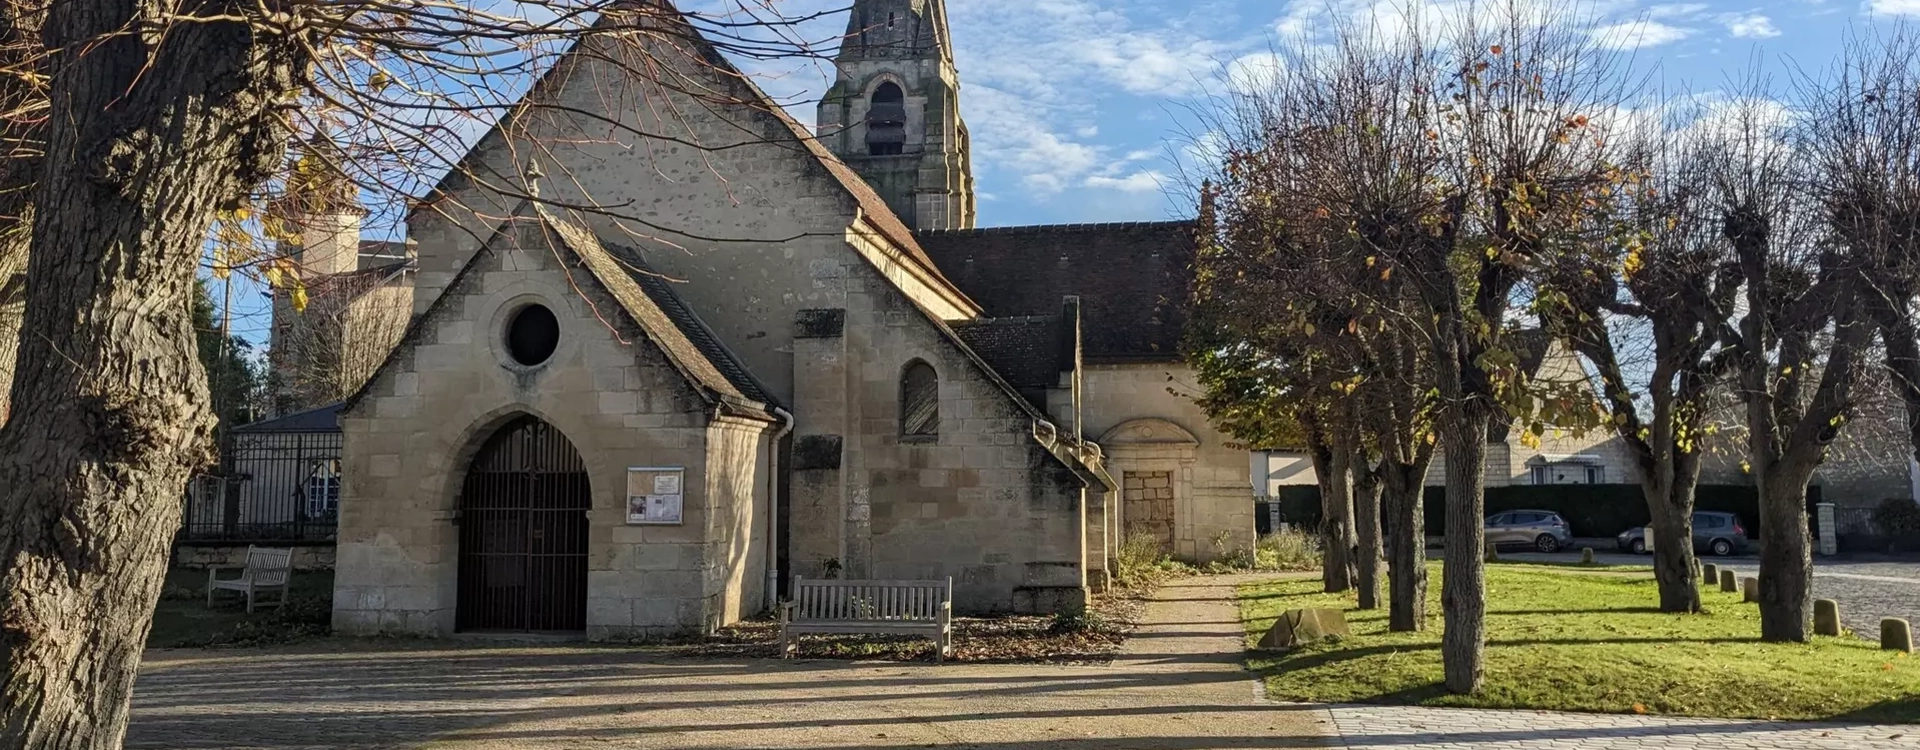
[{"left": 534, "top": 205, "right": 776, "bottom": 412}]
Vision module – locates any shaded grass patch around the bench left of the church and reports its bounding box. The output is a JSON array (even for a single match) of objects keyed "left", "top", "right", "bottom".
[{"left": 146, "top": 568, "right": 334, "bottom": 648}]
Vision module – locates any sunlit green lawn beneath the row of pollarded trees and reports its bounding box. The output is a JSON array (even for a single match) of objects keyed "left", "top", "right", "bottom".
[{"left": 1240, "top": 564, "right": 1920, "bottom": 723}]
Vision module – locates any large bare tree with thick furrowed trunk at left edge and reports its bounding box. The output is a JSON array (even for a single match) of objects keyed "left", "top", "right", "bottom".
[{"left": 0, "top": 0, "right": 837, "bottom": 748}]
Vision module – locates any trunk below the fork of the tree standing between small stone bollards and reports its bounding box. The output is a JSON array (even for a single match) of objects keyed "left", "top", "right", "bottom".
[{"left": 1761, "top": 464, "right": 1812, "bottom": 643}]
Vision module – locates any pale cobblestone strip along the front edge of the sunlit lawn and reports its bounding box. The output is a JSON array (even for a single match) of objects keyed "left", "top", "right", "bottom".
[{"left": 1332, "top": 706, "right": 1920, "bottom": 750}]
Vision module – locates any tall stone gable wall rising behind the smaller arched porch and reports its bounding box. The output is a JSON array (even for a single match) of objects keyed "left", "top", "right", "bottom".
[{"left": 409, "top": 5, "right": 977, "bottom": 399}]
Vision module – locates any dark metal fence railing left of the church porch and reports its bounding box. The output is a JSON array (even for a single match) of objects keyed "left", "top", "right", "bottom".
[{"left": 182, "top": 432, "right": 342, "bottom": 541}]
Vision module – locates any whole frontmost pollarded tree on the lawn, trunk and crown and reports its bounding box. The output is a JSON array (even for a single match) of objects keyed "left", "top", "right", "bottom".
[{"left": 1394, "top": 0, "right": 1630, "bottom": 692}]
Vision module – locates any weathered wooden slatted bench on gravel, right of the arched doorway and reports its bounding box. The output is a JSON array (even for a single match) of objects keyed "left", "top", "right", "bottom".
[{"left": 780, "top": 575, "right": 954, "bottom": 660}]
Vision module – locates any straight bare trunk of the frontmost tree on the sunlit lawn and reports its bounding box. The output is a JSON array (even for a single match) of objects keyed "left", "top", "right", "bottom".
[{"left": 1440, "top": 408, "right": 1488, "bottom": 694}]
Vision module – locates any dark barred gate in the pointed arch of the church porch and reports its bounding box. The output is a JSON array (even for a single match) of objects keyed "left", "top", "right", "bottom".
[{"left": 457, "top": 416, "right": 593, "bottom": 631}]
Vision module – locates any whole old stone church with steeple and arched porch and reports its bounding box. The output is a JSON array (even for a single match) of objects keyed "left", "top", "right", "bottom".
[{"left": 334, "top": 0, "right": 1254, "bottom": 639}]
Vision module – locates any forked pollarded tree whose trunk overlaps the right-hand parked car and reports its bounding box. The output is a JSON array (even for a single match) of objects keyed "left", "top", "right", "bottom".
[{"left": 1536, "top": 105, "right": 1741, "bottom": 612}]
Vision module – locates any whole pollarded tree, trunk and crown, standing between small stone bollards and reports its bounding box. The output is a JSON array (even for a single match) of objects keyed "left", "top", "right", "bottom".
[{"left": 1701, "top": 82, "right": 1874, "bottom": 641}]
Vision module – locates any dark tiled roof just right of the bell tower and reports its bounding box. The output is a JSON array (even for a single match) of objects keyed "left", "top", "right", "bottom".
[{"left": 916, "top": 221, "right": 1194, "bottom": 363}]
